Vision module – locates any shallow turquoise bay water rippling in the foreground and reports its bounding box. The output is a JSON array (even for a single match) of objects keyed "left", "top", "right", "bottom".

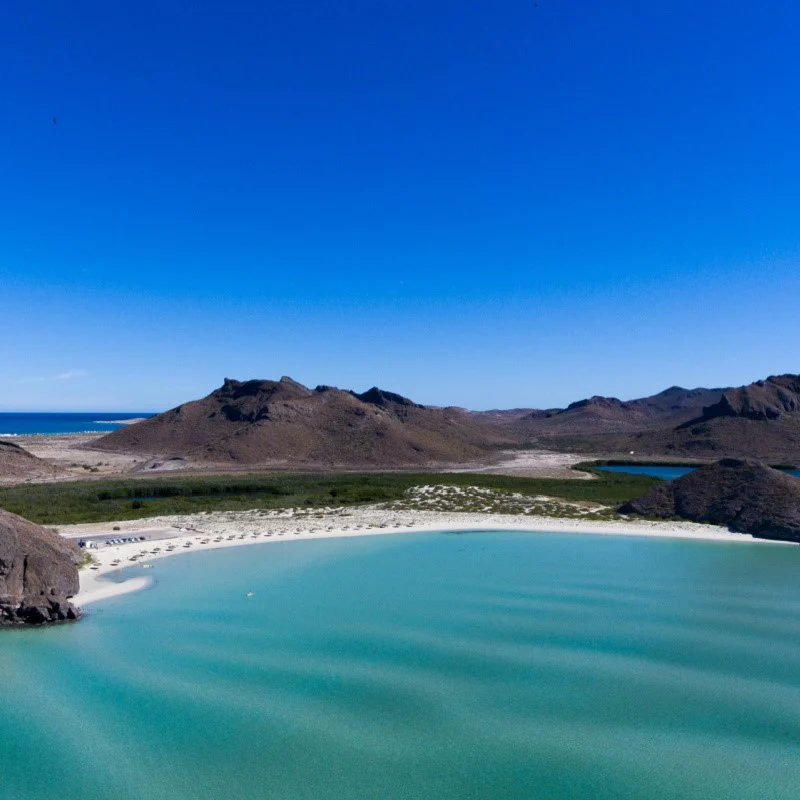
[{"left": 0, "top": 532, "right": 800, "bottom": 800}]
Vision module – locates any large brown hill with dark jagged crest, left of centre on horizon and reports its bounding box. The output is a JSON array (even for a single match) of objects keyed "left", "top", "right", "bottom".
[{"left": 91, "top": 377, "right": 502, "bottom": 468}]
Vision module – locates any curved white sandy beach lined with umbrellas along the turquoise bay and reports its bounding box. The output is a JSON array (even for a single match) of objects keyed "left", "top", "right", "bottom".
[{"left": 65, "top": 506, "right": 783, "bottom": 607}]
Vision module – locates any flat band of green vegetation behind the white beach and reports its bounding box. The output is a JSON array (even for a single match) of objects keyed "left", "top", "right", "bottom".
[{"left": 0, "top": 472, "right": 659, "bottom": 524}]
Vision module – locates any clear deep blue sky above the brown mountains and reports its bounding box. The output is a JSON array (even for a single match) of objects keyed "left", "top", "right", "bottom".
[{"left": 0, "top": 0, "right": 800, "bottom": 410}]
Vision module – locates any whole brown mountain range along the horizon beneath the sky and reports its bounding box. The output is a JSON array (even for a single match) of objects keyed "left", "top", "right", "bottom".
[{"left": 86, "top": 375, "right": 800, "bottom": 469}]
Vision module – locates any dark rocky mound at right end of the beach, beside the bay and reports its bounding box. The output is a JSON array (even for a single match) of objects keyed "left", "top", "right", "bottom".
[{"left": 620, "top": 458, "right": 800, "bottom": 542}]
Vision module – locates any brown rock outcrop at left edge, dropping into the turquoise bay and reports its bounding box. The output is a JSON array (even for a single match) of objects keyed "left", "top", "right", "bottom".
[{"left": 0, "top": 510, "right": 82, "bottom": 626}]
